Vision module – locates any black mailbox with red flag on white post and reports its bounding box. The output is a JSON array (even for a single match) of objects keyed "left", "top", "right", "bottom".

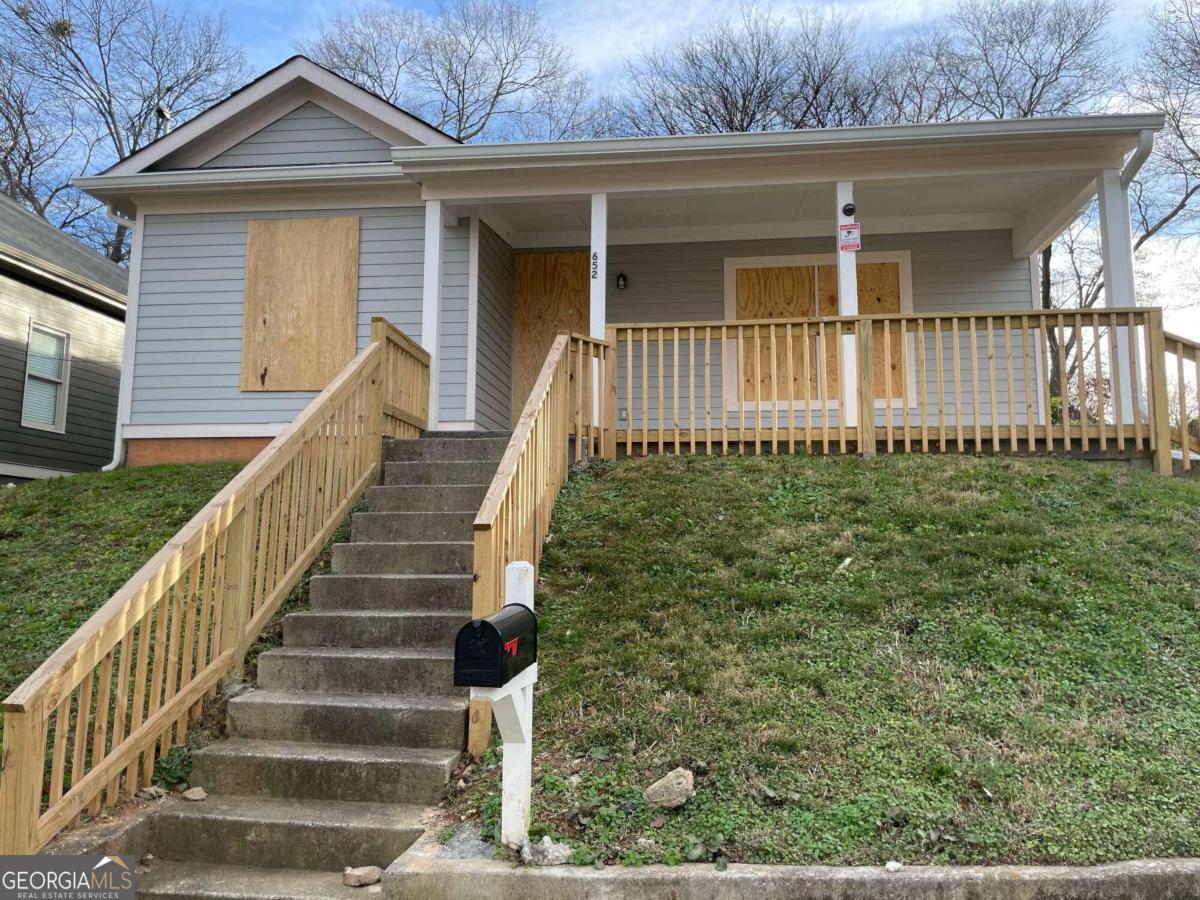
[{"left": 454, "top": 604, "right": 538, "bottom": 688}]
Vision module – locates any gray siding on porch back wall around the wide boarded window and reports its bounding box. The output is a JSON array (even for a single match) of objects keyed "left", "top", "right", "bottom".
[{"left": 585, "top": 230, "right": 1037, "bottom": 427}]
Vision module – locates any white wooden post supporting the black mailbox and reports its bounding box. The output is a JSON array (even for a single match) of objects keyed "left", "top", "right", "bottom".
[{"left": 470, "top": 563, "right": 538, "bottom": 847}]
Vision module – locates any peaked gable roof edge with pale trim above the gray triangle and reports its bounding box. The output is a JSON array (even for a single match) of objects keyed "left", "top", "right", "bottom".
[{"left": 100, "top": 55, "right": 460, "bottom": 176}]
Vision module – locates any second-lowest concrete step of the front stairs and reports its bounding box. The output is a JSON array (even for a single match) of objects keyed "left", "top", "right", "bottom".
[{"left": 151, "top": 796, "right": 424, "bottom": 871}]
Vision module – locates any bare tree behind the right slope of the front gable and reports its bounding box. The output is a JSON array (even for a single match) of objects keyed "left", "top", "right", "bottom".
[{"left": 300, "top": 0, "right": 578, "bottom": 140}]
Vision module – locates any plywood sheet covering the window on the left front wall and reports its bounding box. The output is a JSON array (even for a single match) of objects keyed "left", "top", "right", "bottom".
[{"left": 241, "top": 216, "right": 359, "bottom": 392}]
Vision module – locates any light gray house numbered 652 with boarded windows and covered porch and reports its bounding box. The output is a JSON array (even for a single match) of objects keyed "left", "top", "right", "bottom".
[{"left": 79, "top": 56, "right": 1162, "bottom": 463}]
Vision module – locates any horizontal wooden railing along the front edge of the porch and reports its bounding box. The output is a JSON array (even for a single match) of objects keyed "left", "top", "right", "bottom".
[{"left": 608, "top": 308, "right": 1171, "bottom": 475}]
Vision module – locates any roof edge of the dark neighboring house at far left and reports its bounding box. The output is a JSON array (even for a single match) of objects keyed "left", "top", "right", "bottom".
[{"left": 0, "top": 194, "right": 130, "bottom": 312}]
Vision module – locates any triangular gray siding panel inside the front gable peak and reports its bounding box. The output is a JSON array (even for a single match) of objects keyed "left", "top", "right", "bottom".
[{"left": 203, "top": 102, "right": 391, "bottom": 169}]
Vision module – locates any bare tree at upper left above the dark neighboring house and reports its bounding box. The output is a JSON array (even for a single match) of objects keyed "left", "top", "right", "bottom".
[{"left": 0, "top": 0, "right": 244, "bottom": 262}]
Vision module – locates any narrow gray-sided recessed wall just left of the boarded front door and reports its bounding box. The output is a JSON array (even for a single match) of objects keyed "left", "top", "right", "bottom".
[{"left": 475, "top": 223, "right": 515, "bottom": 431}]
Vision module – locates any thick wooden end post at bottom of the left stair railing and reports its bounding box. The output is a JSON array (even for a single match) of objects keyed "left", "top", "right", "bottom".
[{"left": 0, "top": 701, "right": 43, "bottom": 854}]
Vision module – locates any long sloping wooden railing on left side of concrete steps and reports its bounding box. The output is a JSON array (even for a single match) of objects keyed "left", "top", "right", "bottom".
[{"left": 0, "top": 320, "right": 428, "bottom": 853}]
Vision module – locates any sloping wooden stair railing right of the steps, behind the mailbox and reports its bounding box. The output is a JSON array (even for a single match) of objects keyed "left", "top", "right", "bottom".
[{"left": 467, "top": 335, "right": 616, "bottom": 756}]
